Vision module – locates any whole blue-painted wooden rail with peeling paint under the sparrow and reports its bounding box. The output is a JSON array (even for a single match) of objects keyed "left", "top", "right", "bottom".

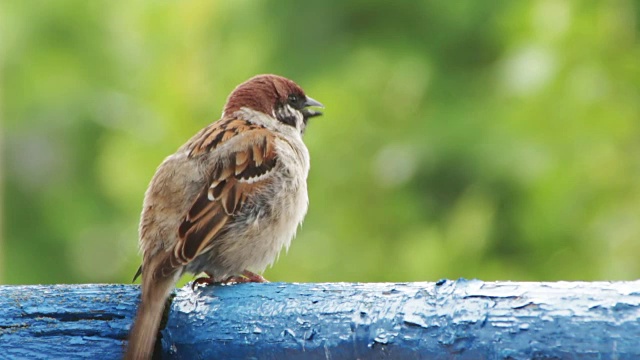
[{"left": 0, "top": 279, "right": 640, "bottom": 359}]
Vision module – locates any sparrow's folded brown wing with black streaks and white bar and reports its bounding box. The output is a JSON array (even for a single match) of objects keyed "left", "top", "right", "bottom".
[{"left": 172, "top": 120, "right": 277, "bottom": 265}]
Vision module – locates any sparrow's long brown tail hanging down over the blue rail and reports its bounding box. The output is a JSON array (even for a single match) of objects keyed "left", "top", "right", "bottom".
[{"left": 124, "top": 266, "right": 179, "bottom": 360}]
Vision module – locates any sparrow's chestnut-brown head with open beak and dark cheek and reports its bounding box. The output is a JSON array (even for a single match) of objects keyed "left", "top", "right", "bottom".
[{"left": 223, "top": 75, "right": 324, "bottom": 132}]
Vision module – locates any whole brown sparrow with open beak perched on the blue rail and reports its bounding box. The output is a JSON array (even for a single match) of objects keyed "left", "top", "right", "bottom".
[{"left": 125, "top": 75, "right": 323, "bottom": 359}]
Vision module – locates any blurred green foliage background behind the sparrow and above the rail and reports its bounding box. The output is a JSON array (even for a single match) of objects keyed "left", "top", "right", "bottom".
[{"left": 0, "top": 0, "right": 640, "bottom": 284}]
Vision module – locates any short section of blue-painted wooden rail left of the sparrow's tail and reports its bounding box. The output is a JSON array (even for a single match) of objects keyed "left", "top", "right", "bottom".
[{"left": 0, "top": 285, "right": 138, "bottom": 359}]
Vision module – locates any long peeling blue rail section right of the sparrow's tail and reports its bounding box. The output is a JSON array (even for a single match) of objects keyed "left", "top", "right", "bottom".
[{"left": 163, "top": 279, "right": 640, "bottom": 359}]
